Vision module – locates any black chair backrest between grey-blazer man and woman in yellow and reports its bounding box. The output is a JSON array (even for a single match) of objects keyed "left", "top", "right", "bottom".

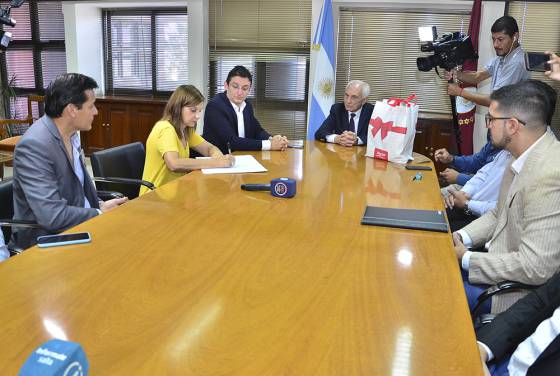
[{"left": 91, "top": 142, "right": 146, "bottom": 199}]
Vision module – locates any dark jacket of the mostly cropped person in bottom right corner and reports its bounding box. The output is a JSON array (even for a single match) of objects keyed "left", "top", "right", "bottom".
[{"left": 476, "top": 273, "right": 560, "bottom": 375}]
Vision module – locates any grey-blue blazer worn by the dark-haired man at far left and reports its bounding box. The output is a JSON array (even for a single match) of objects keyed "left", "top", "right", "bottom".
[{"left": 12, "top": 116, "right": 99, "bottom": 249}]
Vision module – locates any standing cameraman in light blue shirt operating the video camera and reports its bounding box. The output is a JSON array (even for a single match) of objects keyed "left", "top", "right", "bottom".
[{"left": 445, "top": 16, "right": 530, "bottom": 107}]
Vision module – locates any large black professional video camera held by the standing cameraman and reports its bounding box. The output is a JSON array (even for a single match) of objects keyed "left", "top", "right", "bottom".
[{"left": 416, "top": 26, "right": 478, "bottom": 72}]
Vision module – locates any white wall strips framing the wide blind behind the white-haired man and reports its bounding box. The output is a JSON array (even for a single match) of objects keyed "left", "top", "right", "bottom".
[{"left": 309, "top": 0, "right": 505, "bottom": 151}]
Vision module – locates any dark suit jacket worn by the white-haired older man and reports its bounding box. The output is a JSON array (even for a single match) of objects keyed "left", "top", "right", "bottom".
[{"left": 315, "top": 103, "right": 373, "bottom": 144}]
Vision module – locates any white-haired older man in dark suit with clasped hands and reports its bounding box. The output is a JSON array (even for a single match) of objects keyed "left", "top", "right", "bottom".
[{"left": 315, "top": 80, "right": 373, "bottom": 146}]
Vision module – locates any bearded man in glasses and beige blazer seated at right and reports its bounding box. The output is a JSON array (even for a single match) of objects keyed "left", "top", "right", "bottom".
[{"left": 453, "top": 81, "right": 560, "bottom": 313}]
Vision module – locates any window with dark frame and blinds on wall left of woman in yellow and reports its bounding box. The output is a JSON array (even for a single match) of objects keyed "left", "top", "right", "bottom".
[{"left": 103, "top": 9, "right": 189, "bottom": 96}]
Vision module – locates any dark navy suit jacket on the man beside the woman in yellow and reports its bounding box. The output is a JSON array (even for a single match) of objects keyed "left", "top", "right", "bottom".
[{"left": 202, "top": 92, "right": 270, "bottom": 154}]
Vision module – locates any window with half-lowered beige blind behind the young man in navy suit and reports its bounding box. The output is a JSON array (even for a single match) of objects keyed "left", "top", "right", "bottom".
[{"left": 208, "top": 0, "right": 311, "bottom": 138}]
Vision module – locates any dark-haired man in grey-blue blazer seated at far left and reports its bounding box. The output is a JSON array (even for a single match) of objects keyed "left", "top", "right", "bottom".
[{"left": 12, "top": 73, "right": 127, "bottom": 249}]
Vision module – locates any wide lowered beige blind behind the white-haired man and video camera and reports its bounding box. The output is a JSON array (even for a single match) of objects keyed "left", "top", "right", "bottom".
[{"left": 335, "top": 8, "right": 470, "bottom": 113}]
